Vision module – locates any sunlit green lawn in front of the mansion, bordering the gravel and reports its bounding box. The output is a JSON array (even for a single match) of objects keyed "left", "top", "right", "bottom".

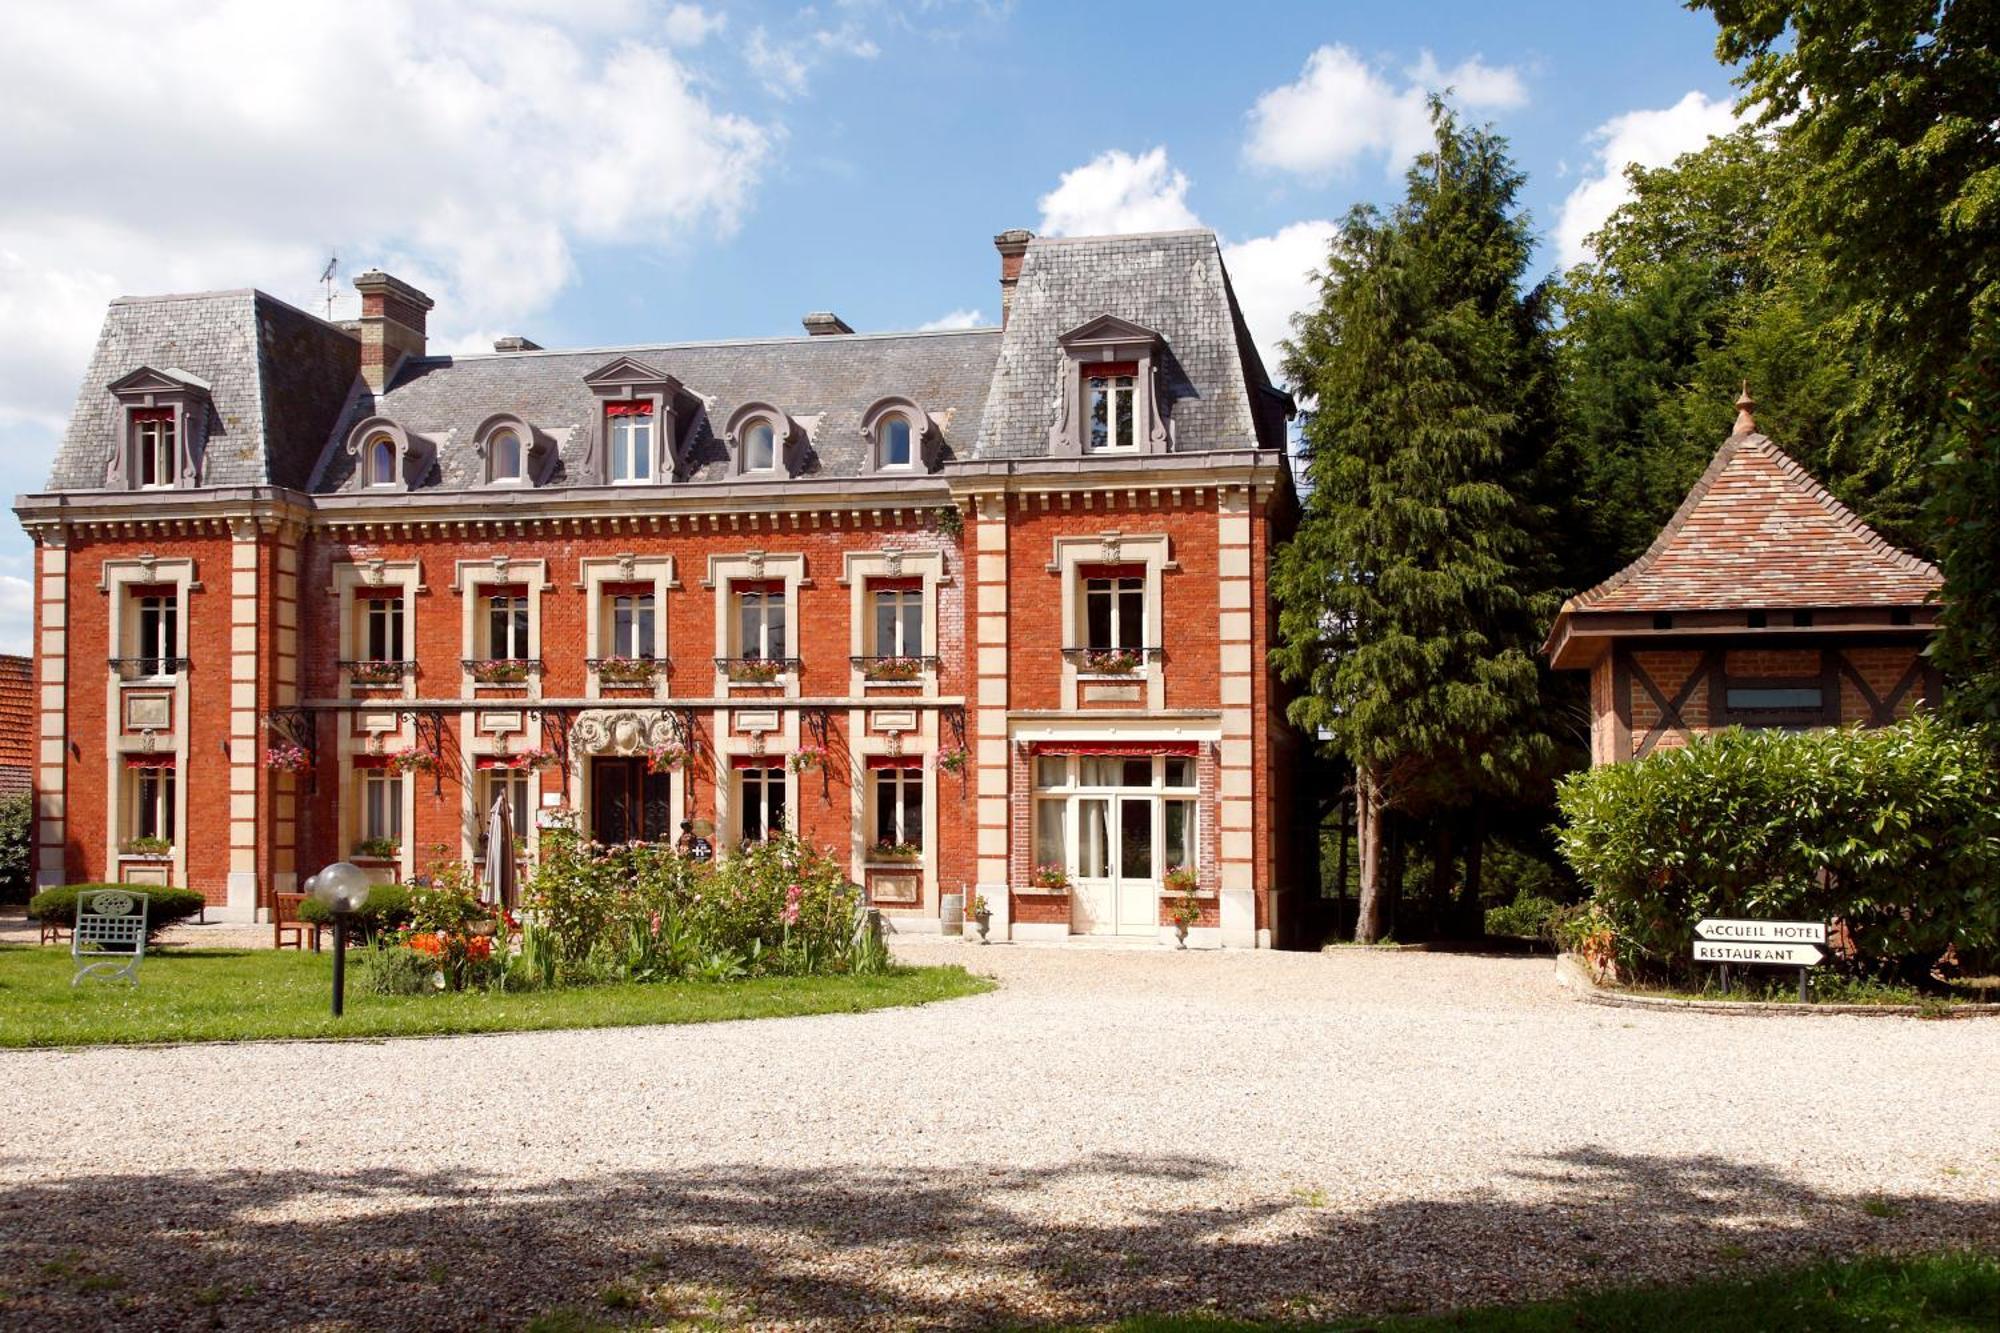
[{"left": 0, "top": 945, "right": 992, "bottom": 1047}]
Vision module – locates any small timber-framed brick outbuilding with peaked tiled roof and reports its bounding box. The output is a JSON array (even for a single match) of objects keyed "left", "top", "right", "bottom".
[{"left": 1546, "top": 394, "right": 1942, "bottom": 765}]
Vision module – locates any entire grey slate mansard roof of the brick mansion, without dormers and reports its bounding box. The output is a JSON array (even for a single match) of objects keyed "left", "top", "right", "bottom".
[{"left": 48, "top": 230, "right": 1290, "bottom": 492}]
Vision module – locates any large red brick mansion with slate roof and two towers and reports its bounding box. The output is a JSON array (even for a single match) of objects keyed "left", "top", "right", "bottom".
[{"left": 16, "top": 232, "right": 1298, "bottom": 947}]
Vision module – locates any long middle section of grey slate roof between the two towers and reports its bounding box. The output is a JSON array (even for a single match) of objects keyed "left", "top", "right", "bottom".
[{"left": 314, "top": 328, "right": 1000, "bottom": 490}]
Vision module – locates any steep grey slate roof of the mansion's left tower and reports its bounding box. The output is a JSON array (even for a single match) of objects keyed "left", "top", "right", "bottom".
[{"left": 48, "top": 288, "right": 360, "bottom": 490}]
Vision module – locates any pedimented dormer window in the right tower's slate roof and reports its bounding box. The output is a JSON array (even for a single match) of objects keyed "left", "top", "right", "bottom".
[{"left": 1048, "top": 314, "right": 1172, "bottom": 454}]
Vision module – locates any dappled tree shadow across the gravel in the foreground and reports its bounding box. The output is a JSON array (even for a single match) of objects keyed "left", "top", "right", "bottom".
[{"left": 0, "top": 1129, "right": 2000, "bottom": 1329}]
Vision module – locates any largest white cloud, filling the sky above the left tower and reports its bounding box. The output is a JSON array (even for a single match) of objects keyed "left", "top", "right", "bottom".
[{"left": 0, "top": 0, "right": 772, "bottom": 420}]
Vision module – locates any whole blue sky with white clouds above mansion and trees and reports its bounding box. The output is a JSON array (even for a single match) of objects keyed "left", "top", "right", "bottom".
[{"left": 0, "top": 0, "right": 1730, "bottom": 650}]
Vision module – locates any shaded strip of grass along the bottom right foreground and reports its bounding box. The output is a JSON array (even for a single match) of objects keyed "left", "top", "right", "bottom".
[{"left": 1080, "top": 1253, "right": 2000, "bottom": 1333}]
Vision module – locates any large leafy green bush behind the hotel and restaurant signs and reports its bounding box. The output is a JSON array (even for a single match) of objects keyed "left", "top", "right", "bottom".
[{"left": 1558, "top": 719, "right": 2000, "bottom": 981}]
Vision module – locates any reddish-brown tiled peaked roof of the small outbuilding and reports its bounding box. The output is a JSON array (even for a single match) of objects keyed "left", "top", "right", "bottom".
[{"left": 1562, "top": 432, "right": 1942, "bottom": 612}]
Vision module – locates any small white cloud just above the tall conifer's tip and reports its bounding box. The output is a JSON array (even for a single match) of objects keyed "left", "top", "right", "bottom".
[{"left": 1244, "top": 46, "right": 1528, "bottom": 180}]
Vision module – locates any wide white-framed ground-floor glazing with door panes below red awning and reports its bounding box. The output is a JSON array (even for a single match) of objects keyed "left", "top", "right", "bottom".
[{"left": 1034, "top": 755, "right": 1200, "bottom": 879}]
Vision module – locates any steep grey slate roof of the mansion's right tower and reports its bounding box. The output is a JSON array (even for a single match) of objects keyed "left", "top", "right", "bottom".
[{"left": 972, "top": 230, "right": 1284, "bottom": 458}]
